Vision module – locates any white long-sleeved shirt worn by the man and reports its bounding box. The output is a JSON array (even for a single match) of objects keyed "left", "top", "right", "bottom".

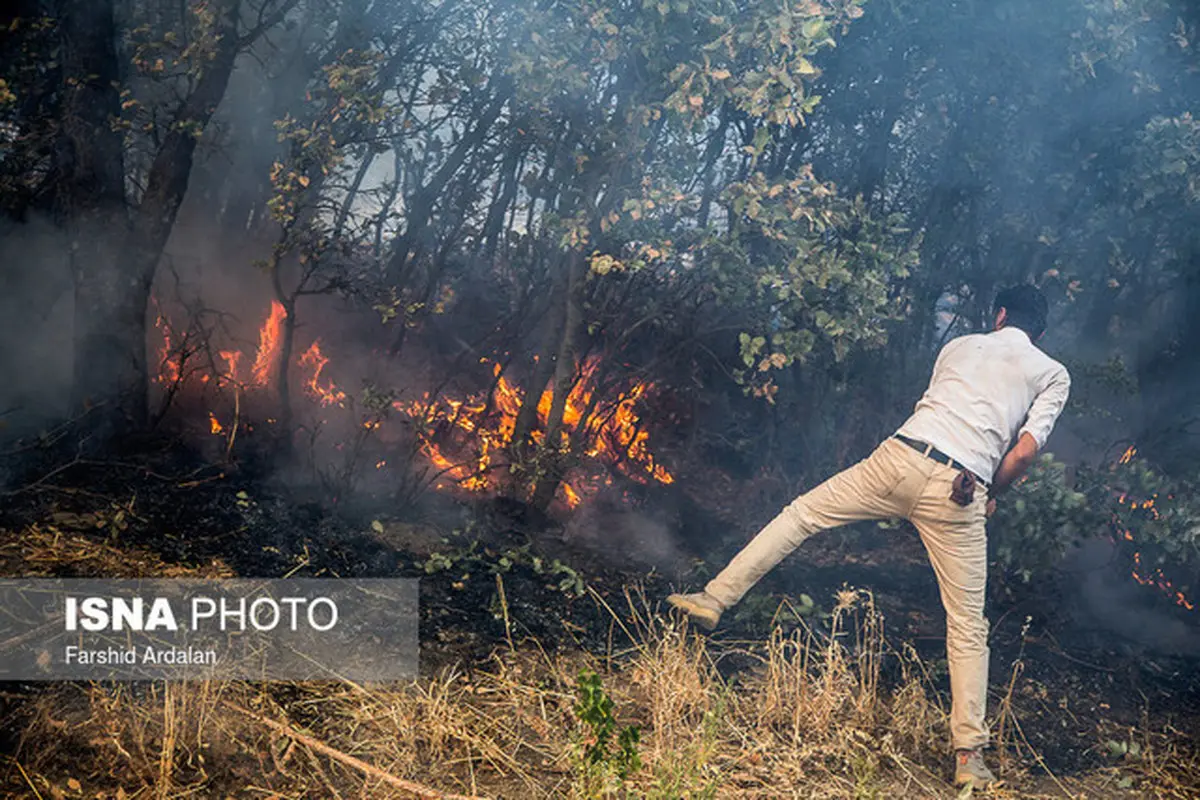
[{"left": 898, "top": 327, "right": 1070, "bottom": 482}]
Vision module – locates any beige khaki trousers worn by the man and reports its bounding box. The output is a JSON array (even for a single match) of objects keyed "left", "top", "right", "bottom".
[{"left": 706, "top": 439, "right": 989, "bottom": 748}]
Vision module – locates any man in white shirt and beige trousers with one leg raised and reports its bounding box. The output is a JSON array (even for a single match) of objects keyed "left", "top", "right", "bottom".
[{"left": 667, "top": 285, "right": 1070, "bottom": 789}]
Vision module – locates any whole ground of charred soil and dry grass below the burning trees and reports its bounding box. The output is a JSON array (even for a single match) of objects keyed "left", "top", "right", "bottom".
[{"left": 0, "top": 447, "right": 1200, "bottom": 798}]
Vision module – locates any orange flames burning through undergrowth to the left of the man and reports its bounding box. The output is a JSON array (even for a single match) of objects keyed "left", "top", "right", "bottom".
[{"left": 148, "top": 301, "right": 674, "bottom": 509}]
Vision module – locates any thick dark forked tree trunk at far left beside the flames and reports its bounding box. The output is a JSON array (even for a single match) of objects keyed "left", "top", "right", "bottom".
[{"left": 60, "top": 0, "right": 239, "bottom": 429}]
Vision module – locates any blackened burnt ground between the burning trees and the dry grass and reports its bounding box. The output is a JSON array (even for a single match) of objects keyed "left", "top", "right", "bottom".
[{"left": 0, "top": 443, "right": 1200, "bottom": 796}]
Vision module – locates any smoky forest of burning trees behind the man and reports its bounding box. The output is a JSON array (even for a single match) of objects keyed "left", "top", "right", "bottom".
[{"left": 0, "top": 0, "right": 1200, "bottom": 604}]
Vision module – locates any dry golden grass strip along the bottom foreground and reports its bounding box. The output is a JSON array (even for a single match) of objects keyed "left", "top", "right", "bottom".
[{"left": 0, "top": 522, "right": 1200, "bottom": 800}]
